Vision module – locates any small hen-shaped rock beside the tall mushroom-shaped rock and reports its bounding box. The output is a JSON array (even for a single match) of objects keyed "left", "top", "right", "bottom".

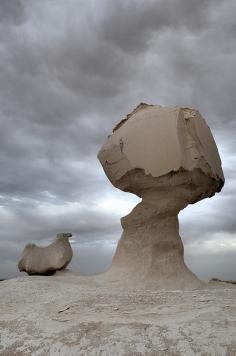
[{"left": 18, "top": 233, "right": 73, "bottom": 275}]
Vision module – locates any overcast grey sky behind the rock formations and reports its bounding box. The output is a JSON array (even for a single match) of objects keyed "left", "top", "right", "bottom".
[{"left": 0, "top": 0, "right": 236, "bottom": 279}]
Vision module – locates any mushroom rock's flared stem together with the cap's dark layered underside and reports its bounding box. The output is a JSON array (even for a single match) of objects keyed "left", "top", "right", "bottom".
[{"left": 100, "top": 170, "right": 218, "bottom": 289}]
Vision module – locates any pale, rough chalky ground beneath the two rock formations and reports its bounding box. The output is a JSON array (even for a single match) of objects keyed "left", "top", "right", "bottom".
[{"left": 0, "top": 272, "right": 236, "bottom": 356}]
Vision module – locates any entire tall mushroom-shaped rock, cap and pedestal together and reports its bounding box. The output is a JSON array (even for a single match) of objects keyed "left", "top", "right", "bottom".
[{"left": 98, "top": 103, "right": 224, "bottom": 289}]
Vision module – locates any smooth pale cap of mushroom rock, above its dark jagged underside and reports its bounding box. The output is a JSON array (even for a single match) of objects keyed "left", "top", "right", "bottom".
[{"left": 98, "top": 103, "right": 224, "bottom": 199}]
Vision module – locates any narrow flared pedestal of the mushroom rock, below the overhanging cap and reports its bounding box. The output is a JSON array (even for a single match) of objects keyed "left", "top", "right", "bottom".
[{"left": 106, "top": 179, "right": 203, "bottom": 289}]
